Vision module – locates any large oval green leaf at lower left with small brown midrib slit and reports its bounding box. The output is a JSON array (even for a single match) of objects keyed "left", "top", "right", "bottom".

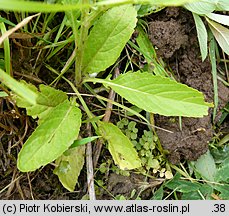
[{"left": 17, "top": 101, "right": 81, "bottom": 172}]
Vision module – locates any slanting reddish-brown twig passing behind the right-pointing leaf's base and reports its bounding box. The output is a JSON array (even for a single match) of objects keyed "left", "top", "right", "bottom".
[{"left": 93, "top": 66, "right": 119, "bottom": 168}]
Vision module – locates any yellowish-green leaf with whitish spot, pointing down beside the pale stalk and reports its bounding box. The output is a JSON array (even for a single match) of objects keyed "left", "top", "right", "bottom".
[{"left": 53, "top": 146, "right": 85, "bottom": 191}]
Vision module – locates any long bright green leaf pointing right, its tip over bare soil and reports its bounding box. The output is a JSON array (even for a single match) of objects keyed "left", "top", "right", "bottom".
[{"left": 91, "top": 72, "right": 212, "bottom": 117}]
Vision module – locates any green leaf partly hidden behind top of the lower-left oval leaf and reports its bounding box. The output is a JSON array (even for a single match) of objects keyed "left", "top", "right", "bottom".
[{"left": 14, "top": 84, "right": 68, "bottom": 121}]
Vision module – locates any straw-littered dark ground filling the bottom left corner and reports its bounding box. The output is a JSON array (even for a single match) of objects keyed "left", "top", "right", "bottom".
[{"left": 0, "top": 98, "right": 86, "bottom": 200}]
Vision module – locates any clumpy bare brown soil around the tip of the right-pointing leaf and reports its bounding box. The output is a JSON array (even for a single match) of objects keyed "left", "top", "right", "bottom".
[{"left": 149, "top": 8, "right": 229, "bottom": 163}]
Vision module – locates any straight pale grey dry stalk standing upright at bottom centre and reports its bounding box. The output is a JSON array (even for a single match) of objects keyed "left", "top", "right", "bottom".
[{"left": 86, "top": 123, "right": 96, "bottom": 200}]
